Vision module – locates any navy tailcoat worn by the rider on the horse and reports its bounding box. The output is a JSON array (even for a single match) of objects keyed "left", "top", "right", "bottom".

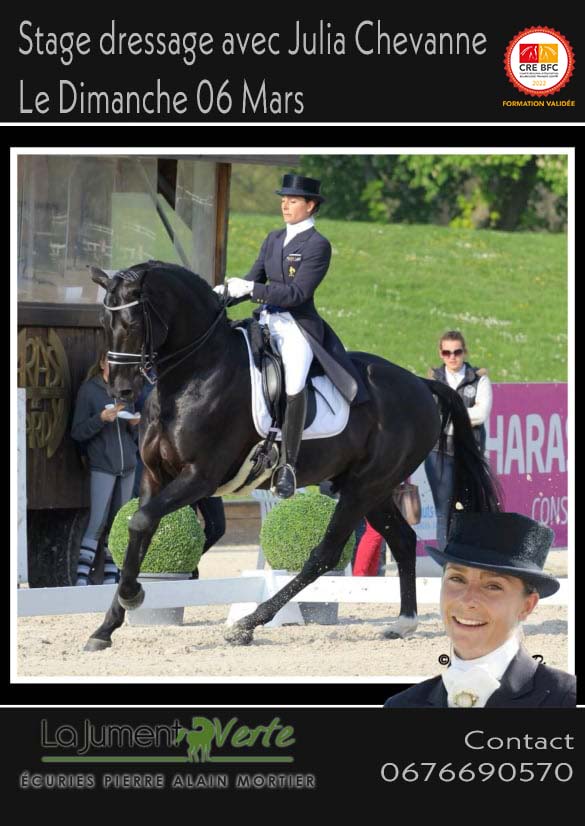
[{"left": 235, "top": 227, "right": 369, "bottom": 404}]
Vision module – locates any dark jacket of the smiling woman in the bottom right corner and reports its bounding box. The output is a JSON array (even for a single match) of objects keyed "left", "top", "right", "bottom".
[{"left": 384, "top": 648, "right": 577, "bottom": 708}]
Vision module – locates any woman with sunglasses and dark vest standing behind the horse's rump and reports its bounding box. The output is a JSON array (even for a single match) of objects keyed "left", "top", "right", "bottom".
[{"left": 425, "top": 330, "right": 492, "bottom": 549}]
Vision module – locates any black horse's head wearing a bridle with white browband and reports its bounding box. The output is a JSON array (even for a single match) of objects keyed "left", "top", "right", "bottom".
[{"left": 90, "top": 267, "right": 147, "bottom": 401}]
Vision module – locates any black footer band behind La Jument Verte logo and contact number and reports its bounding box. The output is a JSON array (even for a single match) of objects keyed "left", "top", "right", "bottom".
[{"left": 0, "top": 706, "right": 584, "bottom": 810}]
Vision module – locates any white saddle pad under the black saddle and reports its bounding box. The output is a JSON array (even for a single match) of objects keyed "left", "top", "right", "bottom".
[{"left": 236, "top": 327, "right": 349, "bottom": 439}]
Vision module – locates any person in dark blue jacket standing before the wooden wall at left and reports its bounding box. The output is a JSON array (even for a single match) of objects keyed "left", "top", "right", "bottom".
[{"left": 71, "top": 350, "right": 140, "bottom": 585}]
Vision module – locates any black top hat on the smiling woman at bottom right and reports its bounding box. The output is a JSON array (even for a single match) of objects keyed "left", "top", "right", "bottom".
[{"left": 425, "top": 513, "right": 560, "bottom": 597}]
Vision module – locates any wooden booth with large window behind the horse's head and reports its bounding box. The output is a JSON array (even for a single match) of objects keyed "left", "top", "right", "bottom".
[{"left": 18, "top": 155, "right": 298, "bottom": 587}]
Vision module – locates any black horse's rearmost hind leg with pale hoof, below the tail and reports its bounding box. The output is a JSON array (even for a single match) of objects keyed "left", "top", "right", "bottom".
[{"left": 366, "top": 500, "right": 418, "bottom": 639}]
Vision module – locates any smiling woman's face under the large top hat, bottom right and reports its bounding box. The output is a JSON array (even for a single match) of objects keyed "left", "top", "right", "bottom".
[{"left": 441, "top": 562, "right": 538, "bottom": 660}]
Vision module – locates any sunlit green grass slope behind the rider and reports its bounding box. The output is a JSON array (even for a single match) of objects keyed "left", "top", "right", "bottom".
[{"left": 227, "top": 213, "right": 568, "bottom": 382}]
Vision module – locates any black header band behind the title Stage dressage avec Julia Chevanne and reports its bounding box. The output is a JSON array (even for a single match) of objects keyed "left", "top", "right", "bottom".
[{"left": 0, "top": 3, "right": 584, "bottom": 124}]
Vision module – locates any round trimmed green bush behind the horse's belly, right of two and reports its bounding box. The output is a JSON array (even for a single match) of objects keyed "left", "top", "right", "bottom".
[{"left": 260, "top": 493, "right": 355, "bottom": 571}]
